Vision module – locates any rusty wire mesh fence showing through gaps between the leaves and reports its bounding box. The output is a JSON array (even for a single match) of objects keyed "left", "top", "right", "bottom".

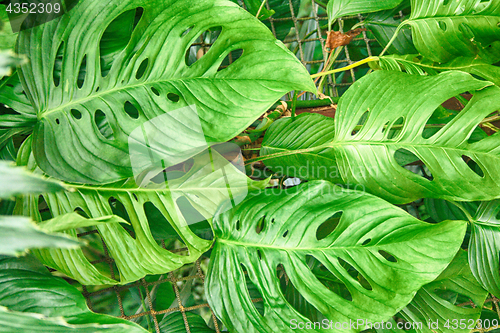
[{"left": 74, "top": 0, "right": 498, "bottom": 333}]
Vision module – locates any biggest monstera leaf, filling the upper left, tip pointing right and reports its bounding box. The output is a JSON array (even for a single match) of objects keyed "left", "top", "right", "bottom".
[{"left": 16, "top": 0, "right": 315, "bottom": 184}]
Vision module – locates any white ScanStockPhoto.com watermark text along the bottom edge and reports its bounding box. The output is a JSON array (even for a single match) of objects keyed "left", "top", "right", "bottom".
[{"left": 290, "top": 319, "right": 424, "bottom": 331}]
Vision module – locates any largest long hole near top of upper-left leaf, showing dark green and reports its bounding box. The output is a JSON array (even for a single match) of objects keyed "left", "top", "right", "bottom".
[{"left": 99, "top": 7, "right": 144, "bottom": 77}]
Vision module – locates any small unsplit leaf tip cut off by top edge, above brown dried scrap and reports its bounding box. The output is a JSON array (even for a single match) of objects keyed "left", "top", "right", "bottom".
[{"left": 326, "top": 0, "right": 403, "bottom": 25}]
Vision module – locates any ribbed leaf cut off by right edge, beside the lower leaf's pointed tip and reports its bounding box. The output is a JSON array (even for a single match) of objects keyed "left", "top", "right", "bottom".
[{"left": 468, "top": 200, "right": 500, "bottom": 297}]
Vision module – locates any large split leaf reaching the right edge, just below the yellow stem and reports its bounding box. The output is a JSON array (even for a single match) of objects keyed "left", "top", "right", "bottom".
[{"left": 260, "top": 71, "right": 500, "bottom": 203}]
